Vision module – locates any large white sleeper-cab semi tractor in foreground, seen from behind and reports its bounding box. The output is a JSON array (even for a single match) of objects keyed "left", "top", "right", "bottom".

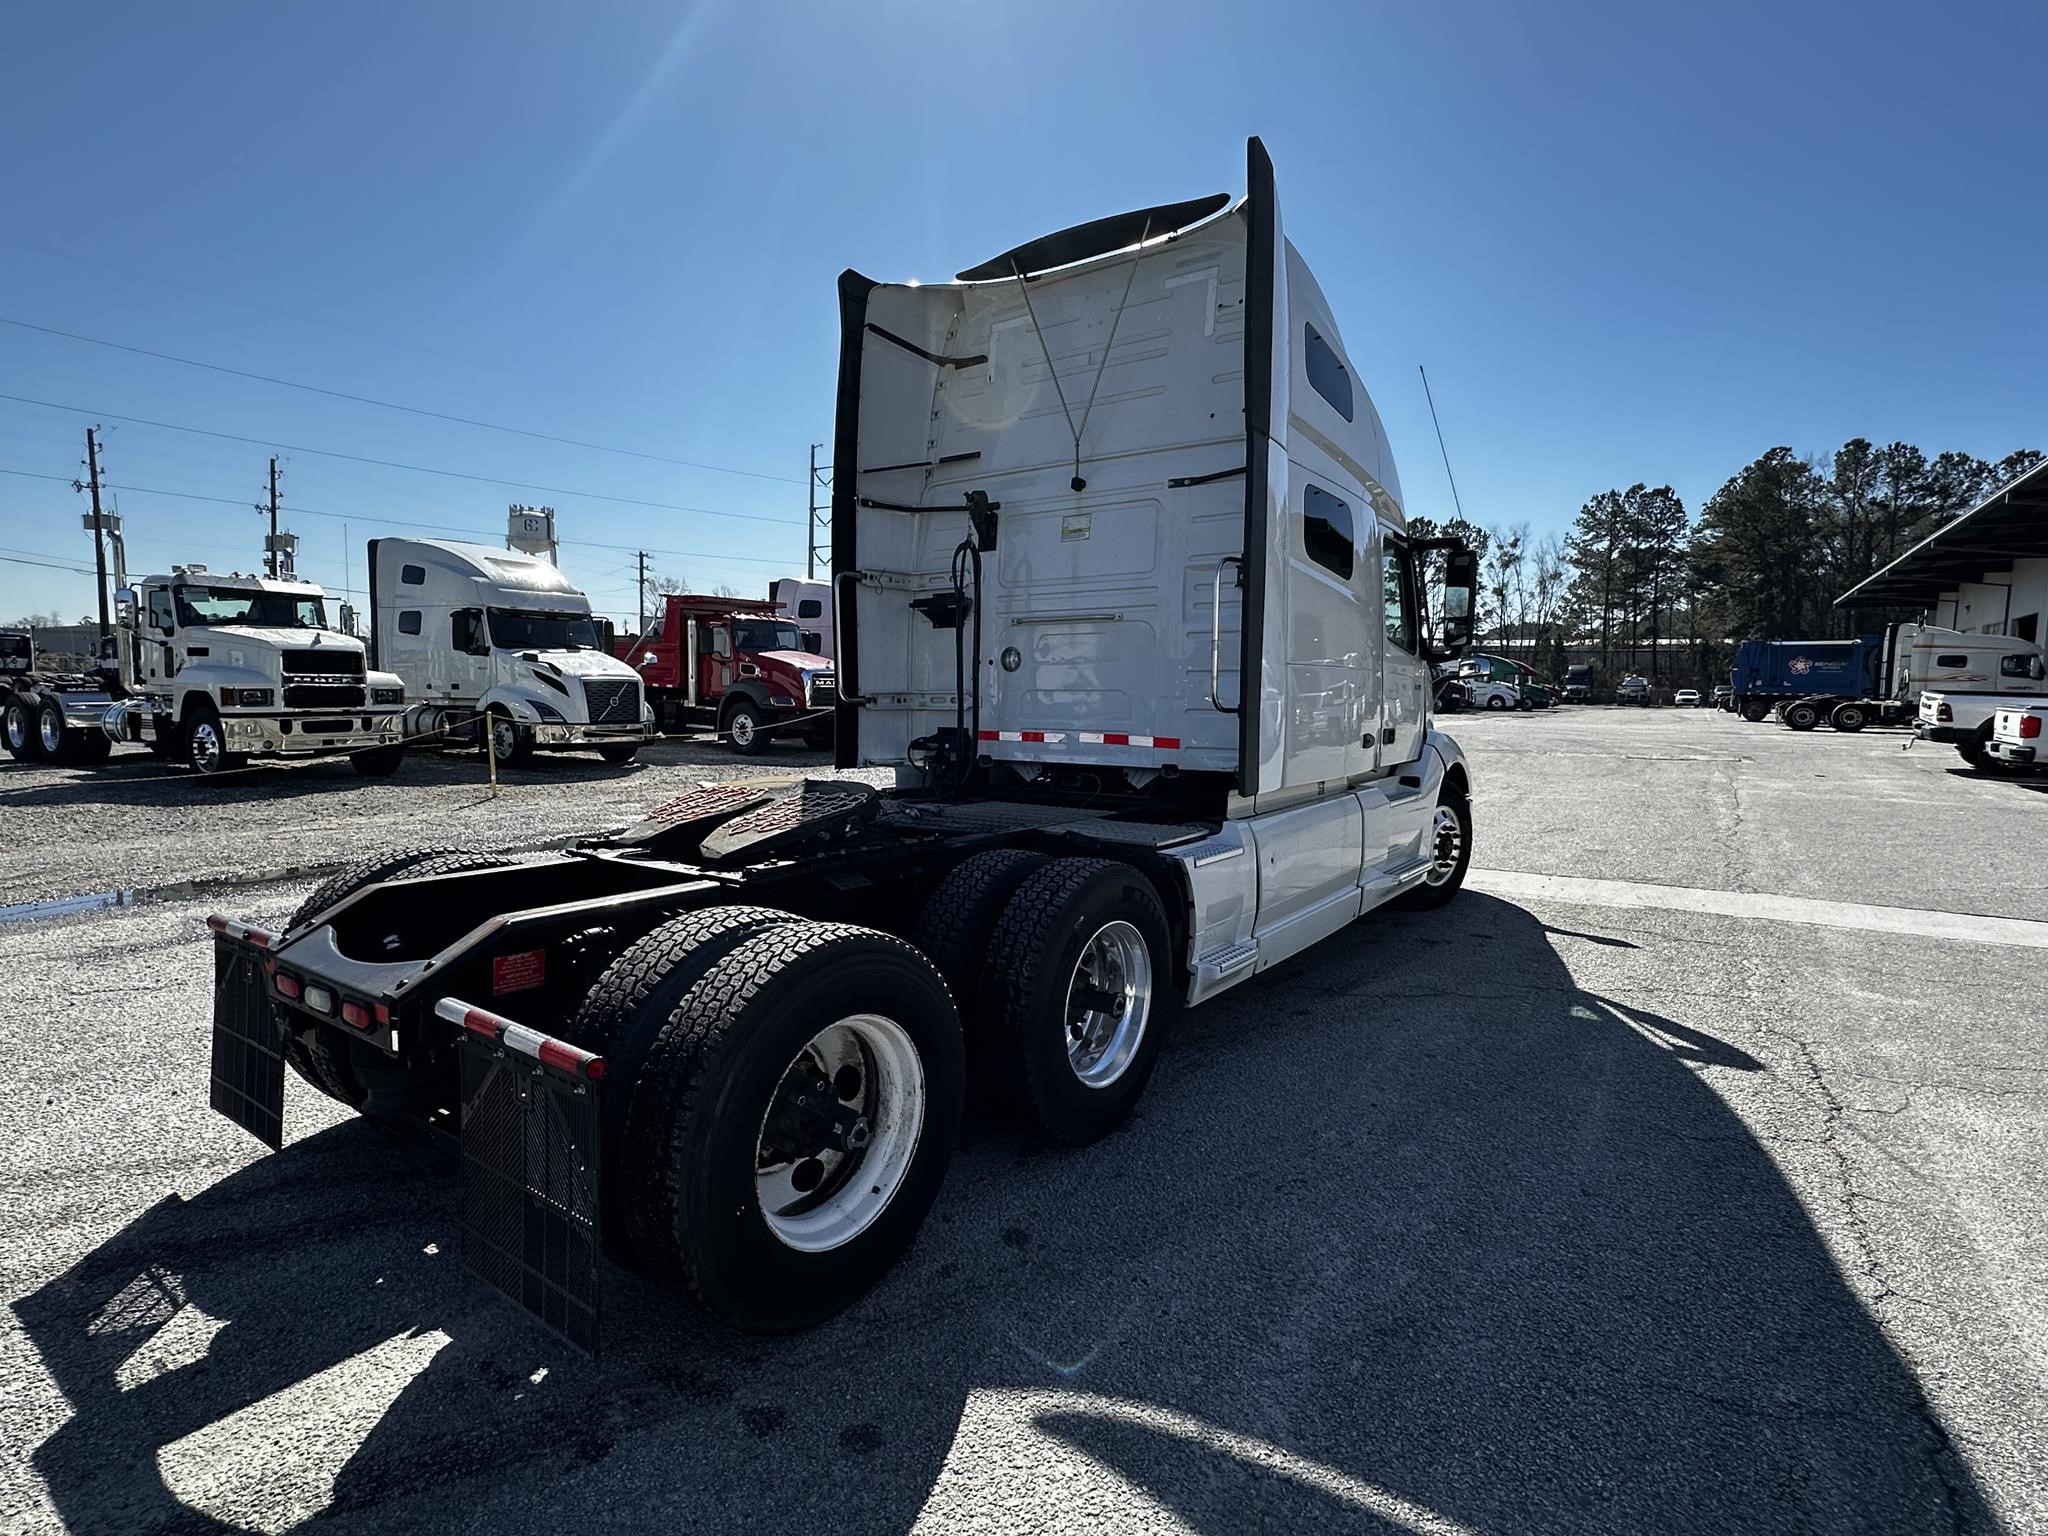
[{"left": 213, "top": 139, "right": 1477, "bottom": 1346}]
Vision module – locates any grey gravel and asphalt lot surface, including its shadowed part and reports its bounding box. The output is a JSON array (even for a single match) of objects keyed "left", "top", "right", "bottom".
[{"left": 0, "top": 709, "right": 2048, "bottom": 1532}]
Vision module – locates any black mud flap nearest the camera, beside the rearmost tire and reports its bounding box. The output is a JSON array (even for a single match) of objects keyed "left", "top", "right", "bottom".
[{"left": 461, "top": 1032, "right": 600, "bottom": 1356}]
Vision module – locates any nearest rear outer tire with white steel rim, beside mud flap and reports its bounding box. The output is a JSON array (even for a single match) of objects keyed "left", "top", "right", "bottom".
[{"left": 635, "top": 922, "right": 965, "bottom": 1333}]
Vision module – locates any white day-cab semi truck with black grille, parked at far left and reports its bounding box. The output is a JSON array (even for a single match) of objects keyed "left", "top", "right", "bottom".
[{"left": 0, "top": 532, "right": 406, "bottom": 778}]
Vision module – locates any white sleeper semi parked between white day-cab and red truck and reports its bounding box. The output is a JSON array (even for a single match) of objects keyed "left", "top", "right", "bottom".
[{"left": 371, "top": 539, "right": 655, "bottom": 764}]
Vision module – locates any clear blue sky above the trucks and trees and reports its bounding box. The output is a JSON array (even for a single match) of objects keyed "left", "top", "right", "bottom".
[{"left": 0, "top": 0, "right": 2048, "bottom": 618}]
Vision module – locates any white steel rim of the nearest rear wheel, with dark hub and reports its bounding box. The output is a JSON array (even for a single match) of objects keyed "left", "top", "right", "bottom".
[{"left": 754, "top": 1014, "right": 928, "bottom": 1253}]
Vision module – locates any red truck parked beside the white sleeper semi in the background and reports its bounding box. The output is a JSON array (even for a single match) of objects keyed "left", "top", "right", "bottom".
[{"left": 618, "top": 592, "right": 838, "bottom": 754}]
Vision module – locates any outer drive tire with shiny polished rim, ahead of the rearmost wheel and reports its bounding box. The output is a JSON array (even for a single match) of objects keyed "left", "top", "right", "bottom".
[{"left": 977, "top": 858, "right": 1176, "bottom": 1147}]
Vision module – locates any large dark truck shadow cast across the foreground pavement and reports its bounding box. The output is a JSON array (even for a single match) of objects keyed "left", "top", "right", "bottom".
[{"left": 16, "top": 893, "right": 1995, "bottom": 1536}]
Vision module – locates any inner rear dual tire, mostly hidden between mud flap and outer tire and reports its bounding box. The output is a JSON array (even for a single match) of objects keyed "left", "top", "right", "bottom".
[{"left": 569, "top": 907, "right": 799, "bottom": 1255}]
